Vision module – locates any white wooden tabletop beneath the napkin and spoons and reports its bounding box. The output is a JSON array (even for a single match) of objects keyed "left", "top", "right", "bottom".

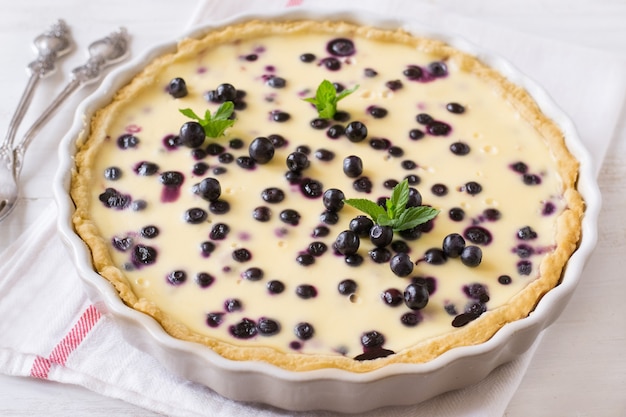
[{"left": 0, "top": 0, "right": 626, "bottom": 417}]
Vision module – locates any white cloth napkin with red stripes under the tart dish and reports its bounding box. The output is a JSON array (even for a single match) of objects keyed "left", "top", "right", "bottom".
[{"left": 0, "top": 0, "right": 626, "bottom": 417}]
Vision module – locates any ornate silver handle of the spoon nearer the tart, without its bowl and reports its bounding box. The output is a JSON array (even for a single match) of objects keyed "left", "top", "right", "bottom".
[{"left": 13, "top": 28, "right": 129, "bottom": 175}]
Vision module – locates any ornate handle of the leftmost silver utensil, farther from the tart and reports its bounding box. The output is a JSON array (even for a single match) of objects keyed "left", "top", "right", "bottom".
[{"left": 0, "top": 20, "right": 72, "bottom": 151}]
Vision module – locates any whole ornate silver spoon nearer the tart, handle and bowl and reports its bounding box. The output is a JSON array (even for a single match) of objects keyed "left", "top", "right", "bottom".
[{"left": 0, "top": 28, "right": 129, "bottom": 221}]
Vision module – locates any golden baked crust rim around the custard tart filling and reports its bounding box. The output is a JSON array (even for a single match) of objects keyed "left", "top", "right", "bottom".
[{"left": 70, "top": 20, "right": 584, "bottom": 373}]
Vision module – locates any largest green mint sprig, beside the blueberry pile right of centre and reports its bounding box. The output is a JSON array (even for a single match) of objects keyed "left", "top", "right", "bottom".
[{"left": 344, "top": 179, "right": 439, "bottom": 232}]
